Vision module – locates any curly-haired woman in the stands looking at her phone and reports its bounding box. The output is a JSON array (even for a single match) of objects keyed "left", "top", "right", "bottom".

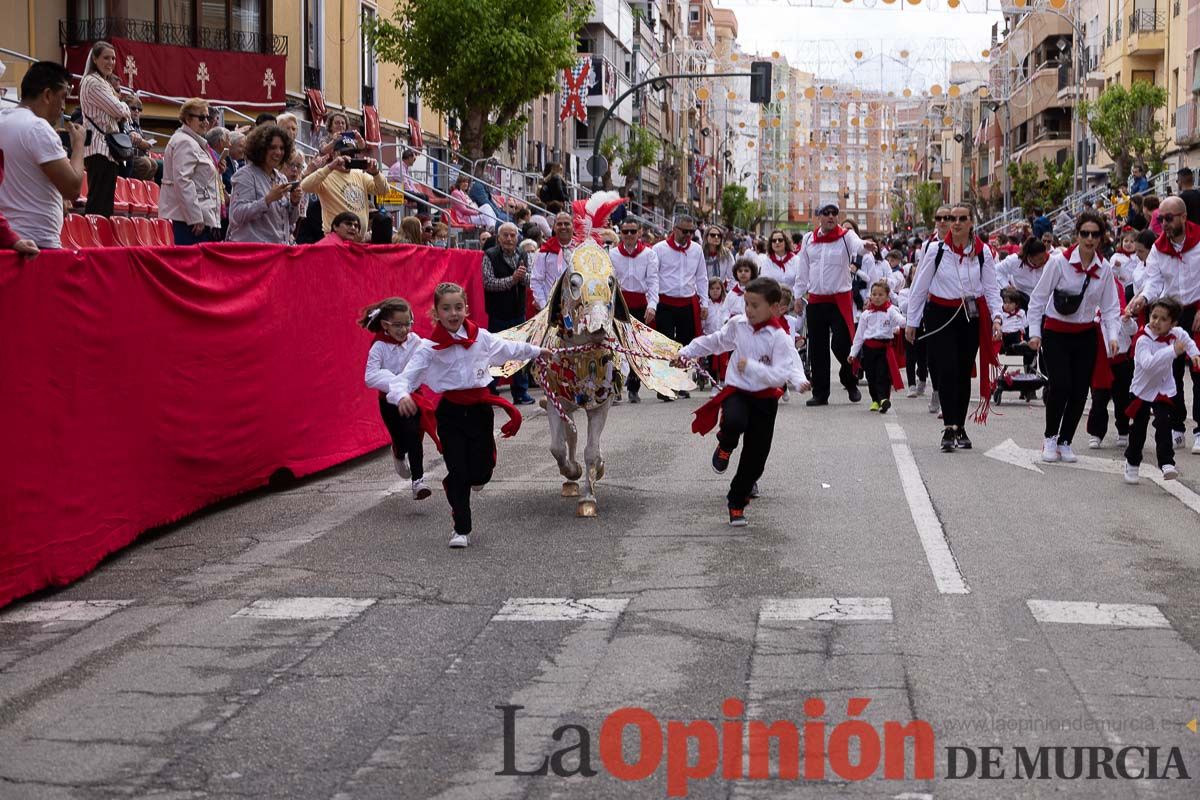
[{"left": 228, "top": 124, "right": 302, "bottom": 245}]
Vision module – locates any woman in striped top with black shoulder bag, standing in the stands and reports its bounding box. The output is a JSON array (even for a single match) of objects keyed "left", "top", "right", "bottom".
[{"left": 79, "top": 42, "right": 133, "bottom": 217}]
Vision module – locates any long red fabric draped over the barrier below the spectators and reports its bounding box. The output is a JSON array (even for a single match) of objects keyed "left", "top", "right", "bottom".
[{"left": 0, "top": 243, "right": 486, "bottom": 607}]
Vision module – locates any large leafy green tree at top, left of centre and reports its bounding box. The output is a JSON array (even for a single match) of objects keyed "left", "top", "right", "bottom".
[{"left": 364, "top": 0, "right": 592, "bottom": 160}]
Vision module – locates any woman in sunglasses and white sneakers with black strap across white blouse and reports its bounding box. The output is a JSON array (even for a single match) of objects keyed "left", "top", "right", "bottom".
[{"left": 1030, "top": 211, "right": 1121, "bottom": 463}]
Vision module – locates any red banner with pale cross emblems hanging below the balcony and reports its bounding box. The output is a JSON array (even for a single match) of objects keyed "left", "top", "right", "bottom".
[{"left": 66, "top": 38, "right": 288, "bottom": 109}]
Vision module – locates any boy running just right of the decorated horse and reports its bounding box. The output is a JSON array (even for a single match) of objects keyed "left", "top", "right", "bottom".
[{"left": 674, "top": 278, "right": 810, "bottom": 527}]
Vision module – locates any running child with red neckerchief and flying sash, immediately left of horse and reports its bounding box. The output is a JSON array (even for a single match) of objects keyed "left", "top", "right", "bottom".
[{"left": 388, "top": 283, "right": 550, "bottom": 547}]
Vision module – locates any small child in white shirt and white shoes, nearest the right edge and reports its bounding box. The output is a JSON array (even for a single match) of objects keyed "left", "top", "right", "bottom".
[{"left": 1124, "top": 297, "right": 1200, "bottom": 483}]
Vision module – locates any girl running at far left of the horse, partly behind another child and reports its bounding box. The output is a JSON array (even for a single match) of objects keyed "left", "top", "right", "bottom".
[{"left": 359, "top": 297, "right": 433, "bottom": 500}]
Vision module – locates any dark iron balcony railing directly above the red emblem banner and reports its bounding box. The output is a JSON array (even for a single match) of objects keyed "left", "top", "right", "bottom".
[{"left": 59, "top": 17, "right": 288, "bottom": 55}]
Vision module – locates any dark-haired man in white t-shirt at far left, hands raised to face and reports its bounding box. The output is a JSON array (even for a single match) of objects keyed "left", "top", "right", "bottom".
[{"left": 0, "top": 61, "right": 84, "bottom": 249}]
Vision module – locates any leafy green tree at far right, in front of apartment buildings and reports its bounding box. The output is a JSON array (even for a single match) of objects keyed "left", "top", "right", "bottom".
[{"left": 1079, "top": 80, "right": 1166, "bottom": 184}]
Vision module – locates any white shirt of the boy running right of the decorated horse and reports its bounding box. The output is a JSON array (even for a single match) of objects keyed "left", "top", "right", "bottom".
[{"left": 679, "top": 314, "right": 805, "bottom": 392}]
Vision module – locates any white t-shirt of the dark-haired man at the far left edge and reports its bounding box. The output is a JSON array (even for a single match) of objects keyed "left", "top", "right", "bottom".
[{"left": 0, "top": 106, "right": 68, "bottom": 249}]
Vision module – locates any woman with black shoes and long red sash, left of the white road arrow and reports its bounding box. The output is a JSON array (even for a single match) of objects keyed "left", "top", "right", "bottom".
[{"left": 905, "top": 203, "right": 1002, "bottom": 452}]
